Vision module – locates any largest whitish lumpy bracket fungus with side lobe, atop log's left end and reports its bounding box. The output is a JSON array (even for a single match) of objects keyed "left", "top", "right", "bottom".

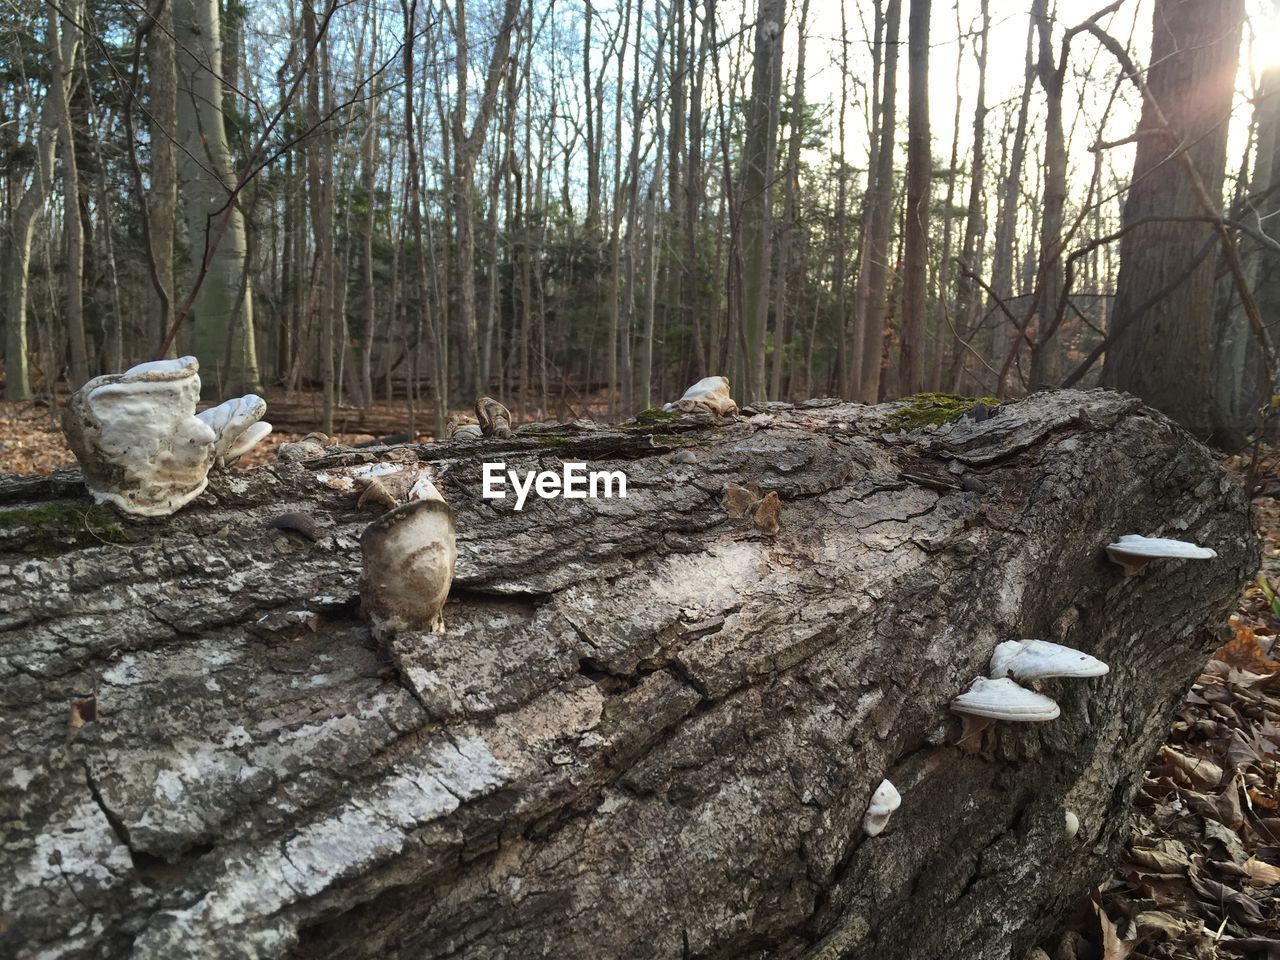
[{"left": 63, "top": 357, "right": 271, "bottom": 517}]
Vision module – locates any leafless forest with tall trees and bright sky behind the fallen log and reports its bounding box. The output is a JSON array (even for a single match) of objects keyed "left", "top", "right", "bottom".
[{"left": 0, "top": 0, "right": 1280, "bottom": 445}]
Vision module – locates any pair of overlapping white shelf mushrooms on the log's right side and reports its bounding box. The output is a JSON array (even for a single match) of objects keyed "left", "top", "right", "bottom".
[{"left": 951, "top": 640, "right": 1110, "bottom": 723}]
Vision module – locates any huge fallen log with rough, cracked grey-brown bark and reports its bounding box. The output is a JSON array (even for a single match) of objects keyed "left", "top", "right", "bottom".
[{"left": 0, "top": 392, "right": 1260, "bottom": 960}]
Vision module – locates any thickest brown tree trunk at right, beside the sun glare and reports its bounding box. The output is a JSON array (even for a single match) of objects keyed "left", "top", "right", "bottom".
[{"left": 1103, "top": 0, "right": 1243, "bottom": 436}]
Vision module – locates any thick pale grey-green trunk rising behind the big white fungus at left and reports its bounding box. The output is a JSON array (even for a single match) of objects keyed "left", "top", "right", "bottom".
[{"left": 173, "top": 0, "right": 261, "bottom": 398}]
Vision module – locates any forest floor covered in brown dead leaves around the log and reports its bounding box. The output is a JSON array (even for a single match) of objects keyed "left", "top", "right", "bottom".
[{"left": 0, "top": 396, "right": 1280, "bottom": 960}]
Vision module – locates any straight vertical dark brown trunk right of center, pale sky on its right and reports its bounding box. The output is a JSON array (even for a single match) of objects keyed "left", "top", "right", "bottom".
[{"left": 899, "top": 0, "right": 933, "bottom": 393}]
